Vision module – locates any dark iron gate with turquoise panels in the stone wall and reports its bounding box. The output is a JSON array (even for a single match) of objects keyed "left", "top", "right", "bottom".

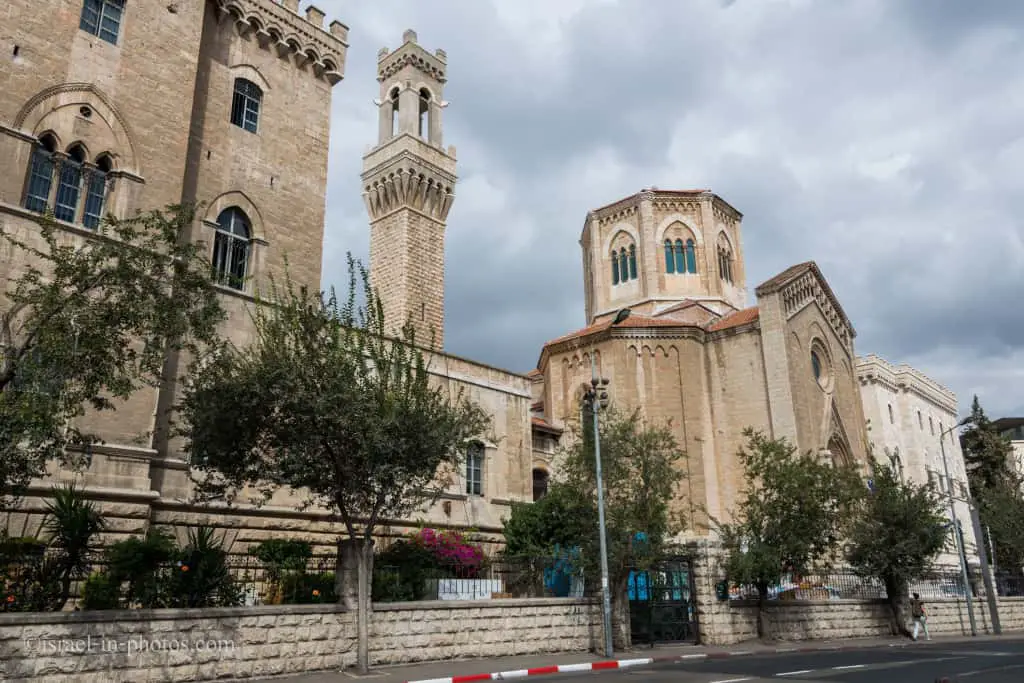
[{"left": 629, "top": 557, "right": 699, "bottom": 646}]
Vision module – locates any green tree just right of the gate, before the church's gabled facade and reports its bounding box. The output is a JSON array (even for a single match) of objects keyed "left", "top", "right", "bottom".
[{"left": 718, "top": 427, "right": 864, "bottom": 638}]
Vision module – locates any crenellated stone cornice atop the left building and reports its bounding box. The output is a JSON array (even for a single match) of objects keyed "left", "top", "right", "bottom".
[{"left": 215, "top": 0, "right": 348, "bottom": 85}]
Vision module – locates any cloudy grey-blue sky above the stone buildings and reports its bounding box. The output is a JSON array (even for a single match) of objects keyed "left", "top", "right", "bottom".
[{"left": 315, "top": 0, "right": 1024, "bottom": 417}]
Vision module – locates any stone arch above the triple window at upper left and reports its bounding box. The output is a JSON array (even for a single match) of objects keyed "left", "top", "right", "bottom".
[{"left": 13, "top": 83, "right": 142, "bottom": 176}]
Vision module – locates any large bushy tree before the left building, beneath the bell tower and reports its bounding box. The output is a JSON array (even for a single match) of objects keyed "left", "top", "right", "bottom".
[{"left": 180, "top": 256, "right": 489, "bottom": 671}]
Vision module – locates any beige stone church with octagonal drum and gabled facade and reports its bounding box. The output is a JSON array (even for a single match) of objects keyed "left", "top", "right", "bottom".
[{"left": 534, "top": 188, "right": 866, "bottom": 536}]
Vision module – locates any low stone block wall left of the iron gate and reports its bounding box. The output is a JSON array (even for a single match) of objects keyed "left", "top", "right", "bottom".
[{"left": 0, "top": 598, "right": 601, "bottom": 683}]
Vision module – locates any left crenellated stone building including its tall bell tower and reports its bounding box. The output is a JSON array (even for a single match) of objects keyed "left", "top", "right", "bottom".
[{"left": 0, "top": 6, "right": 544, "bottom": 550}]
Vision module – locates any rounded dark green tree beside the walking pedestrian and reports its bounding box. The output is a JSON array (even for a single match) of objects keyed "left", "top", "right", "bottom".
[{"left": 847, "top": 461, "right": 949, "bottom": 635}]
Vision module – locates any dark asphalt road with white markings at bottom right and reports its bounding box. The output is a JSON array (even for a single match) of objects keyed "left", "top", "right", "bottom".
[{"left": 588, "top": 640, "right": 1024, "bottom": 683}]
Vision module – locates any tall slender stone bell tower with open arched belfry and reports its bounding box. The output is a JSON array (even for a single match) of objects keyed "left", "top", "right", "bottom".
[{"left": 361, "top": 30, "right": 456, "bottom": 349}]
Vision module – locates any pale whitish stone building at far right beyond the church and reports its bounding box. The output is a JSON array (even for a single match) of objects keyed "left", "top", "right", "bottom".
[{"left": 857, "top": 353, "right": 977, "bottom": 566}]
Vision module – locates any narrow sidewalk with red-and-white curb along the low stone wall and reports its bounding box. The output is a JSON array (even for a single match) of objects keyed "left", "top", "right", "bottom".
[{"left": 245, "top": 634, "right": 1024, "bottom": 683}]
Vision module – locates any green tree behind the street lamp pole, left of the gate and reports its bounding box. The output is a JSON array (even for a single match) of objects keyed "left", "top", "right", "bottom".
[{"left": 542, "top": 410, "right": 686, "bottom": 648}]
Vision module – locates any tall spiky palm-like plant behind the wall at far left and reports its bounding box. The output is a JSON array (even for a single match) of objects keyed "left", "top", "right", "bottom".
[{"left": 43, "top": 483, "right": 106, "bottom": 609}]
